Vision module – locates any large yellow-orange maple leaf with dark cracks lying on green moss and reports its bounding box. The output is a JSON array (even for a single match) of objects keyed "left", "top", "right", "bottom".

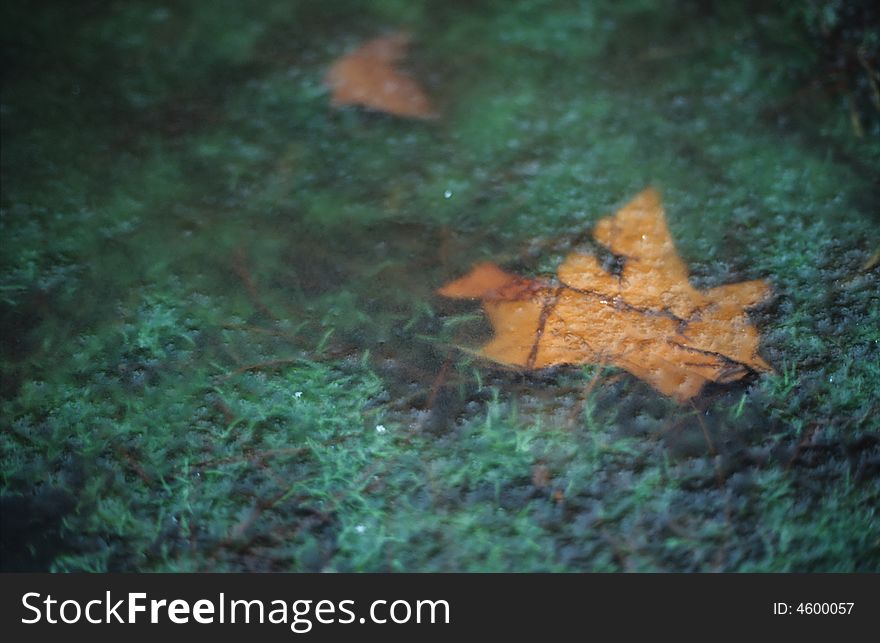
[{"left": 438, "top": 188, "right": 772, "bottom": 402}]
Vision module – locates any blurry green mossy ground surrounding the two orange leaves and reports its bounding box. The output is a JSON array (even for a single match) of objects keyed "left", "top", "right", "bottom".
[{"left": 0, "top": 1, "right": 880, "bottom": 571}]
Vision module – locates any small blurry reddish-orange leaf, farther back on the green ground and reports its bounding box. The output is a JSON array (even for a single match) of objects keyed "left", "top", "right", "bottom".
[{"left": 326, "top": 33, "right": 436, "bottom": 118}]
